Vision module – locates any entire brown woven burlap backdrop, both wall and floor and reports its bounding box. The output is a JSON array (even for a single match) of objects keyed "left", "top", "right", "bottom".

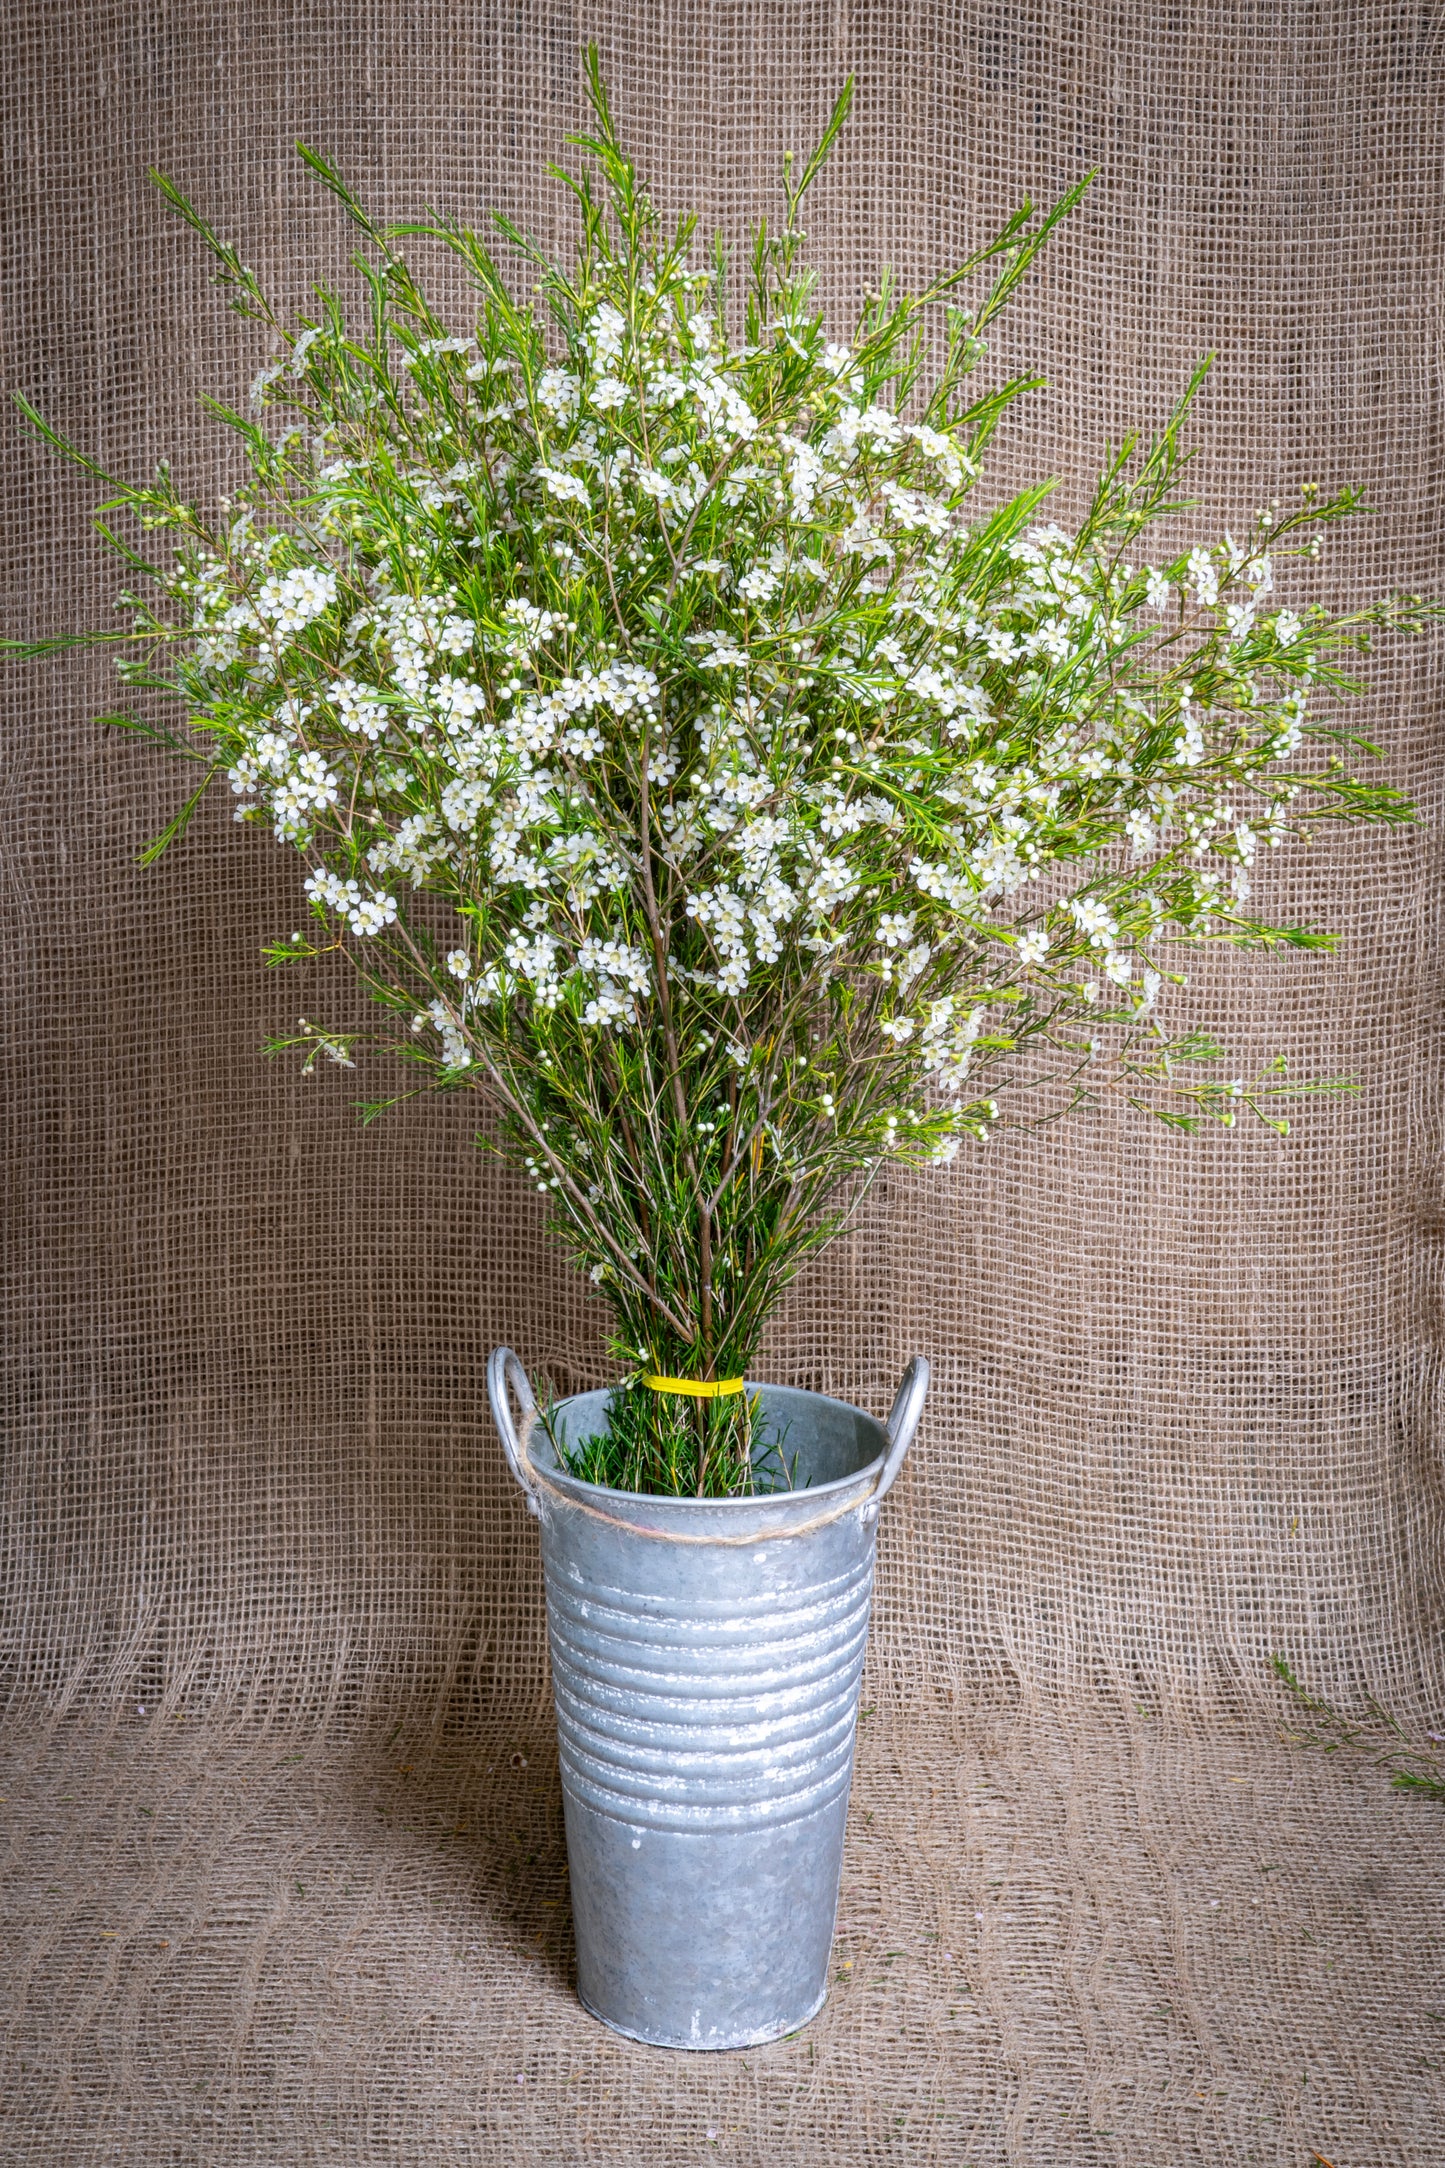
[{"left": 0, "top": 0, "right": 1445, "bottom": 2168}]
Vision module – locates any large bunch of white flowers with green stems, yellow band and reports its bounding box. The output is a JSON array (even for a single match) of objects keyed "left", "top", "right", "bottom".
[{"left": 11, "top": 59, "right": 1426, "bottom": 1496}]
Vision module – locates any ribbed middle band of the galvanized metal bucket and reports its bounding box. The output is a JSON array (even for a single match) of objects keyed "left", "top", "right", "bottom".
[{"left": 546, "top": 1537, "right": 873, "bottom": 1830}]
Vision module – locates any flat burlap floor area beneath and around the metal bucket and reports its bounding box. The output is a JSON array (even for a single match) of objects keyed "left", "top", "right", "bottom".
[{"left": 0, "top": 1702, "right": 1445, "bottom": 2168}]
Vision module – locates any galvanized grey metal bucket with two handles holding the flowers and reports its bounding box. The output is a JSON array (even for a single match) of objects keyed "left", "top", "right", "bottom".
[{"left": 487, "top": 1348, "right": 929, "bottom": 2049}]
